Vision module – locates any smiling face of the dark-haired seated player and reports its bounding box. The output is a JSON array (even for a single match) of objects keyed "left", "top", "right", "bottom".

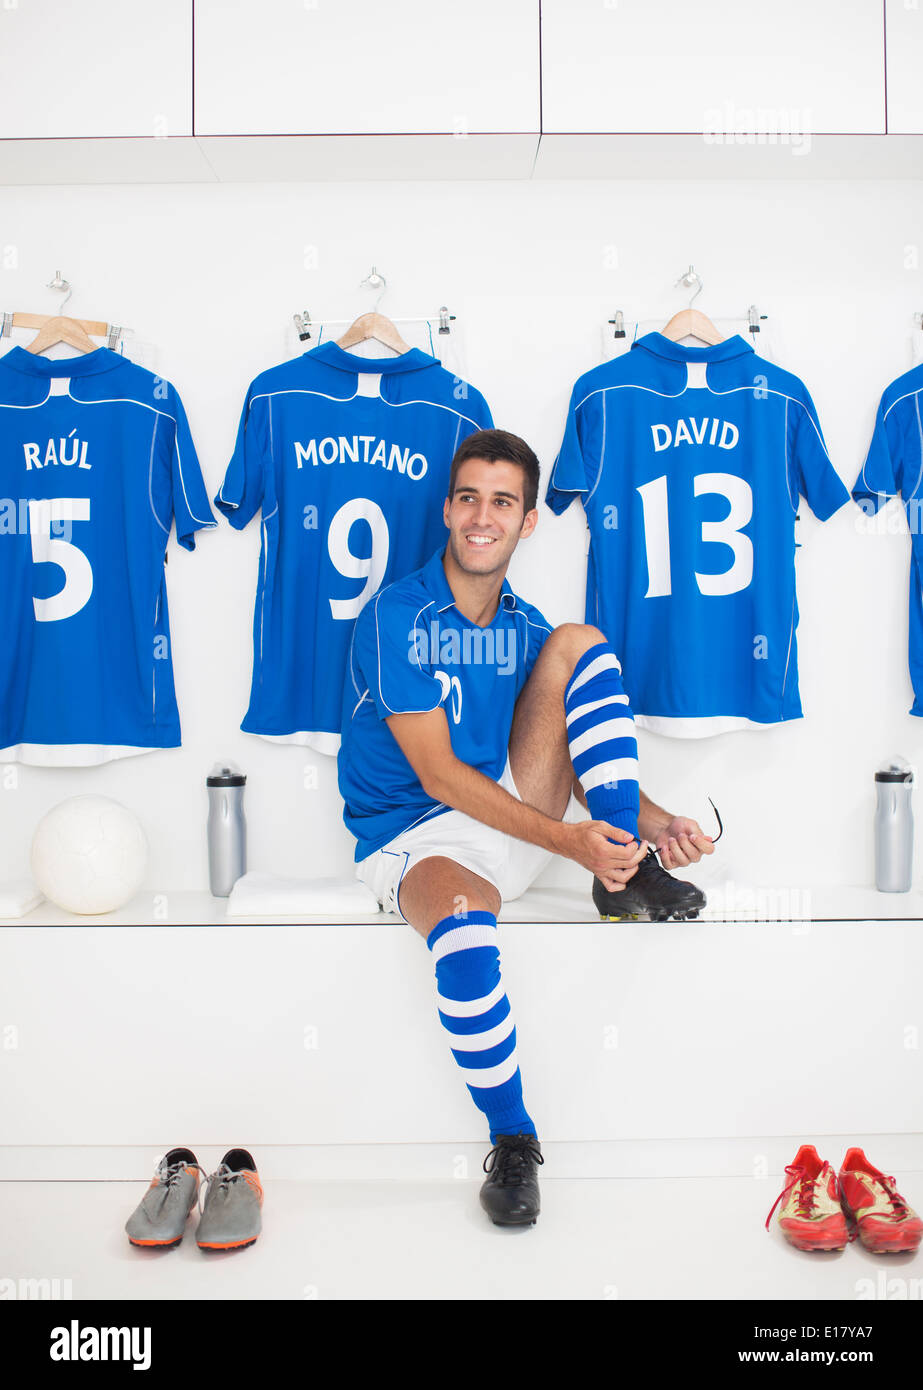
[{"left": 442, "top": 459, "right": 538, "bottom": 574}]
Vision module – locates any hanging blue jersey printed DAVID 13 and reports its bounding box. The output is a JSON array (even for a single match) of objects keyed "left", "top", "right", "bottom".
[{"left": 546, "top": 334, "right": 849, "bottom": 738}]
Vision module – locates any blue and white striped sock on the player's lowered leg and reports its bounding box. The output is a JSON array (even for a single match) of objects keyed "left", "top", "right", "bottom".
[{"left": 427, "top": 912, "right": 535, "bottom": 1144}]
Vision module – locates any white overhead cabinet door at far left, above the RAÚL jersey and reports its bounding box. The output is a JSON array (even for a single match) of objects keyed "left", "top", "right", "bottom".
[{"left": 0, "top": 0, "right": 192, "bottom": 140}]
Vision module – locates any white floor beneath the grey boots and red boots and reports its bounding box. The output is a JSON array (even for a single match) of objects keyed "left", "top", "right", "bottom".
[{"left": 0, "top": 1173, "right": 923, "bottom": 1301}]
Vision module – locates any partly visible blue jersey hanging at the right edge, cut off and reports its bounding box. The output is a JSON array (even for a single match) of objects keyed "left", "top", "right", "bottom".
[{"left": 852, "top": 367, "right": 923, "bottom": 716}]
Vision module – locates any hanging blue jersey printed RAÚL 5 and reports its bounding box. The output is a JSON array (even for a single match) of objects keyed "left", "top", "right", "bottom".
[{"left": 0, "top": 348, "right": 217, "bottom": 766}]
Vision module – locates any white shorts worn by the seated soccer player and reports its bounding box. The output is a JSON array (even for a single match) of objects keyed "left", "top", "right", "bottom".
[{"left": 356, "top": 758, "right": 587, "bottom": 920}]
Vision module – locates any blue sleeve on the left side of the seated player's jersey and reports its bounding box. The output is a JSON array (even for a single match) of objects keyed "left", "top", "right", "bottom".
[{"left": 353, "top": 589, "right": 446, "bottom": 719}]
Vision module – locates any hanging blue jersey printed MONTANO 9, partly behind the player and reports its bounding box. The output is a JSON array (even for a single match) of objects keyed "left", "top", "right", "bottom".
[{"left": 215, "top": 343, "right": 492, "bottom": 753}]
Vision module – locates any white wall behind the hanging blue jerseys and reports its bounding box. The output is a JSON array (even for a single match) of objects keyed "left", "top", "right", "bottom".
[{"left": 0, "top": 181, "right": 923, "bottom": 891}]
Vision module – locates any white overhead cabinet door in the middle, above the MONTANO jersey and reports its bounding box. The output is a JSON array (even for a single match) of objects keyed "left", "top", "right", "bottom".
[{"left": 195, "top": 0, "right": 539, "bottom": 138}]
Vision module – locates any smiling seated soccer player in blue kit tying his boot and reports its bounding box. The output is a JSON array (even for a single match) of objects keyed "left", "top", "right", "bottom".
[{"left": 338, "top": 430, "right": 713, "bottom": 1225}]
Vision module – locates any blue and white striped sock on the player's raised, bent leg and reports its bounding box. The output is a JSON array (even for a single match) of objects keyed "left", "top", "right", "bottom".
[{"left": 564, "top": 642, "right": 639, "bottom": 840}]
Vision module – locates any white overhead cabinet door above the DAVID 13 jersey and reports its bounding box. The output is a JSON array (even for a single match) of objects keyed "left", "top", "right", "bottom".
[{"left": 542, "top": 0, "right": 889, "bottom": 135}]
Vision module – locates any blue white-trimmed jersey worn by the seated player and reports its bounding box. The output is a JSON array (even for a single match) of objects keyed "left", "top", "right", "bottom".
[{"left": 338, "top": 548, "right": 552, "bottom": 862}]
